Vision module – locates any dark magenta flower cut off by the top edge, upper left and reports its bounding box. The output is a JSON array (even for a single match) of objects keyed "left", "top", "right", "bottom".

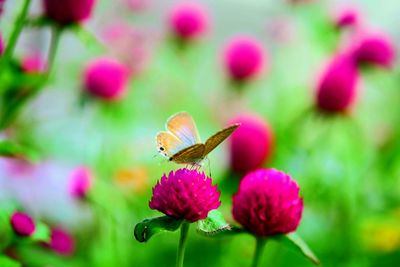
[{"left": 43, "top": 0, "right": 95, "bottom": 25}]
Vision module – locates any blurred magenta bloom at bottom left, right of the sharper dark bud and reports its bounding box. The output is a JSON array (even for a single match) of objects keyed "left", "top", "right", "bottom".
[{"left": 49, "top": 228, "right": 75, "bottom": 256}]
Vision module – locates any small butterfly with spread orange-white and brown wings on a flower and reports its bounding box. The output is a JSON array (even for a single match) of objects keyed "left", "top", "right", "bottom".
[{"left": 156, "top": 112, "right": 240, "bottom": 166}]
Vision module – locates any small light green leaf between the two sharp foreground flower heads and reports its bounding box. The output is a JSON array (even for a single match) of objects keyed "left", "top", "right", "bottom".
[{"left": 197, "top": 210, "right": 231, "bottom": 236}]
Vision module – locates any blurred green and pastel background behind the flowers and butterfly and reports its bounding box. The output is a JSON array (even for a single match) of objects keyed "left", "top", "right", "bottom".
[{"left": 0, "top": 0, "right": 400, "bottom": 267}]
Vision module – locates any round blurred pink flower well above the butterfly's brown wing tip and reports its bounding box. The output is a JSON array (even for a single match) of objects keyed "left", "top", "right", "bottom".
[{"left": 224, "top": 37, "right": 266, "bottom": 81}]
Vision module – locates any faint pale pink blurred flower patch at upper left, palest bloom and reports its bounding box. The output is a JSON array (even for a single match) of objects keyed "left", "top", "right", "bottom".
[{"left": 102, "top": 23, "right": 153, "bottom": 76}]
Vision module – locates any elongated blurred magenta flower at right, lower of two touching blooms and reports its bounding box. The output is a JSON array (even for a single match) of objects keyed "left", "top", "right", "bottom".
[{"left": 315, "top": 53, "right": 359, "bottom": 113}]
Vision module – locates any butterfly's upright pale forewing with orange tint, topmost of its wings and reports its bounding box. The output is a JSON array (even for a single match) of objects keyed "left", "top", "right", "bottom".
[{"left": 166, "top": 112, "right": 201, "bottom": 147}]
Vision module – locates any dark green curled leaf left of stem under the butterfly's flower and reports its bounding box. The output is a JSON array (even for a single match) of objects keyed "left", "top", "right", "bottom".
[{"left": 135, "top": 216, "right": 183, "bottom": 243}]
